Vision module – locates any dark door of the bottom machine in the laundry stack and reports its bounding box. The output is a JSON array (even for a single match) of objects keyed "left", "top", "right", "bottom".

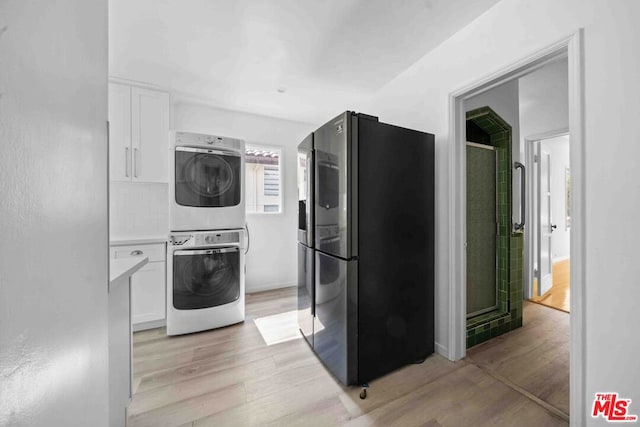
[{"left": 173, "top": 247, "right": 240, "bottom": 310}]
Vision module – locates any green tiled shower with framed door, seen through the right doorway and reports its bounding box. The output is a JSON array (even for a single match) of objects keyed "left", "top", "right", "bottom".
[{"left": 467, "top": 107, "right": 523, "bottom": 348}]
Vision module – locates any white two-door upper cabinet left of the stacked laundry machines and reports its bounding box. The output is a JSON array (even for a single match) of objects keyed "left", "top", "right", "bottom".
[{"left": 109, "top": 83, "right": 170, "bottom": 183}]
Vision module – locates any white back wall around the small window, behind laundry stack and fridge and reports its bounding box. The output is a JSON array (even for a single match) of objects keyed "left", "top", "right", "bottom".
[{"left": 172, "top": 103, "right": 317, "bottom": 292}]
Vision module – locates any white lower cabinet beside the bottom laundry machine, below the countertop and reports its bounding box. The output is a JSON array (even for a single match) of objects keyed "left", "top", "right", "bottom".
[{"left": 111, "top": 243, "right": 166, "bottom": 331}]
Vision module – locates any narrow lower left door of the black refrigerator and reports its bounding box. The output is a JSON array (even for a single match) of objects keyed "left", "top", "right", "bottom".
[{"left": 298, "top": 243, "right": 315, "bottom": 346}]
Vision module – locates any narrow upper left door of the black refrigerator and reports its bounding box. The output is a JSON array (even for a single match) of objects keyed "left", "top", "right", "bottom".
[{"left": 297, "top": 134, "right": 315, "bottom": 247}]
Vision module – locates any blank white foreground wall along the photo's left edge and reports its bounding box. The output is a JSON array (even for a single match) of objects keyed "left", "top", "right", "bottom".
[{"left": 0, "top": 0, "right": 109, "bottom": 426}]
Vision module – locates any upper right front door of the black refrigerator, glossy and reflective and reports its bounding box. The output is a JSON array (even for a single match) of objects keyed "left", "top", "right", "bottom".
[{"left": 314, "top": 112, "right": 352, "bottom": 258}]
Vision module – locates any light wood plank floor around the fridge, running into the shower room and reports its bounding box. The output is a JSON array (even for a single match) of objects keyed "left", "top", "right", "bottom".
[{"left": 128, "top": 288, "right": 569, "bottom": 427}]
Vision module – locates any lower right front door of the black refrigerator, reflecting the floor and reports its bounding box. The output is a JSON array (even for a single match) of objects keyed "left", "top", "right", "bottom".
[{"left": 313, "top": 252, "right": 358, "bottom": 385}]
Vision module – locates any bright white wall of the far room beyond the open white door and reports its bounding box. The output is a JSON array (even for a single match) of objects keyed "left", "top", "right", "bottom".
[{"left": 541, "top": 136, "right": 571, "bottom": 262}]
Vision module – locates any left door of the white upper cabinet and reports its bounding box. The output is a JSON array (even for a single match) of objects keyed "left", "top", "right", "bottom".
[{"left": 109, "top": 83, "right": 131, "bottom": 181}]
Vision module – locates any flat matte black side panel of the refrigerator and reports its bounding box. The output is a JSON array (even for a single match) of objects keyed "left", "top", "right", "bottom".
[{"left": 358, "top": 120, "right": 435, "bottom": 382}]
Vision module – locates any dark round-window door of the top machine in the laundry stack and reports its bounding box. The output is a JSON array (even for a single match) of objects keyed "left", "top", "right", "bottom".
[{"left": 175, "top": 147, "right": 242, "bottom": 207}]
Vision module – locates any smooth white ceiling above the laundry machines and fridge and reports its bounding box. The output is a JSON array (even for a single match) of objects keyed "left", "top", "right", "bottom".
[{"left": 109, "top": 0, "right": 498, "bottom": 123}]
